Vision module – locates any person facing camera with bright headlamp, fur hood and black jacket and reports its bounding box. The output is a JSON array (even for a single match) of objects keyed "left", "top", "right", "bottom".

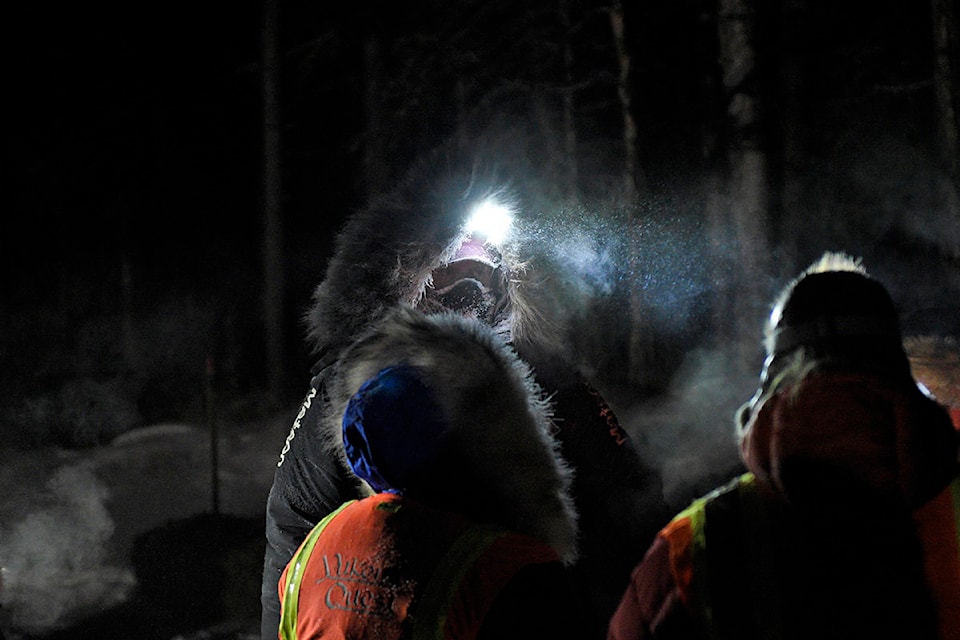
[{"left": 262, "top": 151, "right": 669, "bottom": 640}]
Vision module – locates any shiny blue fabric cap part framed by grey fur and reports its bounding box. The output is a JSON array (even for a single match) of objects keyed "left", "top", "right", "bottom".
[{"left": 343, "top": 365, "right": 446, "bottom": 493}]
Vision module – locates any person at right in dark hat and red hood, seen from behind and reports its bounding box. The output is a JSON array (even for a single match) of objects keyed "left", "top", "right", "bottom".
[{"left": 608, "top": 253, "right": 960, "bottom": 640}]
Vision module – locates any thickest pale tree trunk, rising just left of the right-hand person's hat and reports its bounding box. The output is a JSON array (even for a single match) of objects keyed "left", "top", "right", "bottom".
[{"left": 718, "top": 0, "right": 770, "bottom": 364}]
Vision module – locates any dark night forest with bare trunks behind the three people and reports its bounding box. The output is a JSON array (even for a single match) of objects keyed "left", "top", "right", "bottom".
[{"left": 0, "top": 0, "right": 960, "bottom": 446}]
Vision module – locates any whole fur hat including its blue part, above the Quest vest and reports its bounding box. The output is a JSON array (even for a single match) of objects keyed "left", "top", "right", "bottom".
[{"left": 322, "top": 307, "right": 577, "bottom": 561}]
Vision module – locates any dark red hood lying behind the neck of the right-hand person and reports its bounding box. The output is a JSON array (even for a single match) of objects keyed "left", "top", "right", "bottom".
[{"left": 740, "top": 372, "right": 958, "bottom": 509}]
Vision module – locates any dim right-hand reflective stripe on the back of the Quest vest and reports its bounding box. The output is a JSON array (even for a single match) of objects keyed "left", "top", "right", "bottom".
[{"left": 411, "top": 525, "right": 509, "bottom": 640}]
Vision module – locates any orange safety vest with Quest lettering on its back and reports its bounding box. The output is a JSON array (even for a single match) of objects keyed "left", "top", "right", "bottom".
[{"left": 278, "top": 493, "right": 559, "bottom": 640}]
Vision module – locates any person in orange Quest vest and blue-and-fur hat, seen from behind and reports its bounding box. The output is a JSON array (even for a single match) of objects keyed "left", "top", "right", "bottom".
[{"left": 278, "top": 309, "right": 587, "bottom": 640}]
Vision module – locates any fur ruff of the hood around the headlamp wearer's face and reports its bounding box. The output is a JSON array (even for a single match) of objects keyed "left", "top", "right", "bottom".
[{"left": 305, "top": 150, "right": 556, "bottom": 370}]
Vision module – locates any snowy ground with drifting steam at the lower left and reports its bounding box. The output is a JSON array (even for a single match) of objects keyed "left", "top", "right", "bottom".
[{"left": 0, "top": 416, "right": 288, "bottom": 638}]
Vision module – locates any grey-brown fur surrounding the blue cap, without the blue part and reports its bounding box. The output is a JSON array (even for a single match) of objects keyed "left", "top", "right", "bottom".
[{"left": 322, "top": 307, "right": 577, "bottom": 562}]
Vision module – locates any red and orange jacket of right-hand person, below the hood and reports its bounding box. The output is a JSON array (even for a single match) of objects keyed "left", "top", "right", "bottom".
[{"left": 608, "top": 474, "right": 960, "bottom": 640}]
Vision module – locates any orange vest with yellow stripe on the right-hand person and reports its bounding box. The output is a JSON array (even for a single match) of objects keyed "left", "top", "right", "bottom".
[{"left": 660, "top": 473, "right": 960, "bottom": 640}]
